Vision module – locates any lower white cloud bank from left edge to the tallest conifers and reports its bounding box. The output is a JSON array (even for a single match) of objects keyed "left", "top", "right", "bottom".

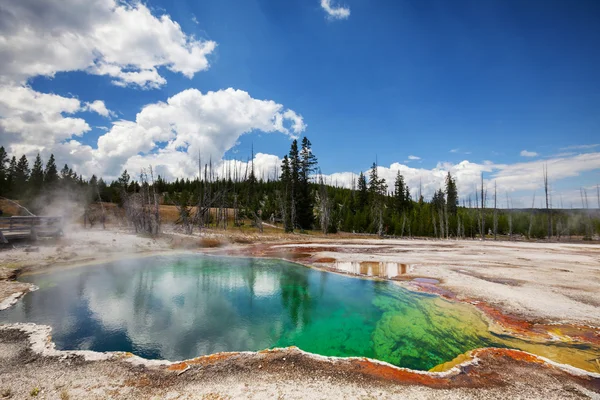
[{"left": 0, "top": 87, "right": 306, "bottom": 178}]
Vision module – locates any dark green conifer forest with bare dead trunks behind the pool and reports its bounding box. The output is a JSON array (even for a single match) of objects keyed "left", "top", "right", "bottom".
[{"left": 0, "top": 143, "right": 600, "bottom": 239}]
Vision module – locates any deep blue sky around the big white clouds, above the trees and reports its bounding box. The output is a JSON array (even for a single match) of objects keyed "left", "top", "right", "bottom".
[{"left": 0, "top": 0, "right": 600, "bottom": 206}]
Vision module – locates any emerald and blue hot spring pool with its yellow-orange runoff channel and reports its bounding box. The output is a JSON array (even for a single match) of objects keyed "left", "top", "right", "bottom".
[{"left": 0, "top": 255, "right": 600, "bottom": 370}]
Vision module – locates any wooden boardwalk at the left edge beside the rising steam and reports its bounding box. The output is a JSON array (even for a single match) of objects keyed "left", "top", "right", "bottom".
[{"left": 0, "top": 216, "right": 63, "bottom": 244}]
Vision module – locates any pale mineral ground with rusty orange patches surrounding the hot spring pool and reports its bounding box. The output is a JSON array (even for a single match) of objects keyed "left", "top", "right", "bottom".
[{"left": 0, "top": 227, "right": 600, "bottom": 399}]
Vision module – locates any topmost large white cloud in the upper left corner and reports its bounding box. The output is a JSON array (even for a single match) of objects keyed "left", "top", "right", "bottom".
[{"left": 0, "top": 0, "right": 216, "bottom": 88}]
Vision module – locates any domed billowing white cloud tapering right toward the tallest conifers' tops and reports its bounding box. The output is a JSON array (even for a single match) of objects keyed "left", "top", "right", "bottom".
[{"left": 98, "top": 88, "right": 305, "bottom": 176}]
